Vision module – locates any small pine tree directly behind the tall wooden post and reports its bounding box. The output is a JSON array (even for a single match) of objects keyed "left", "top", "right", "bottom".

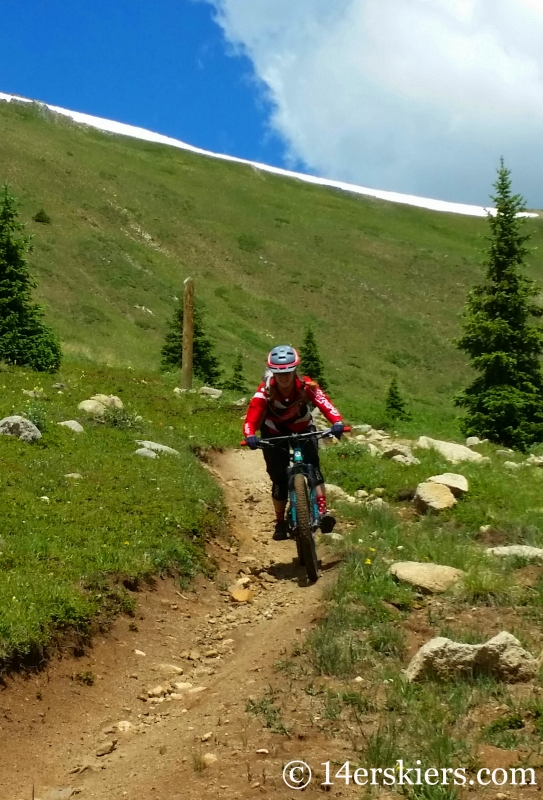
[{"left": 161, "top": 301, "right": 221, "bottom": 386}]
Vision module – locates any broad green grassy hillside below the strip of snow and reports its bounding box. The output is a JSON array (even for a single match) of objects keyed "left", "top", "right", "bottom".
[{"left": 0, "top": 103, "right": 543, "bottom": 432}]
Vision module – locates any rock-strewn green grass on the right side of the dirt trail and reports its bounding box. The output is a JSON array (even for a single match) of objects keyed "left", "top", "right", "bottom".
[{"left": 299, "top": 443, "right": 543, "bottom": 780}]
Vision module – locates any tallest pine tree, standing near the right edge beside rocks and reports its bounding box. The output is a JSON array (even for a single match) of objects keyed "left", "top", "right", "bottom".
[{"left": 455, "top": 159, "right": 543, "bottom": 450}]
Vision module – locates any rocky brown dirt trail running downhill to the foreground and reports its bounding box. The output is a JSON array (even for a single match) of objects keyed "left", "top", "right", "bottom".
[{"left": 0, "top": 452, "right": 345, "bottom": 800}]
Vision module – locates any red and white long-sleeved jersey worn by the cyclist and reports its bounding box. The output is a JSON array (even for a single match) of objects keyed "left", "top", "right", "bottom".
[{"left": 243, "top": 376, "right": 341, "bottom": 436}]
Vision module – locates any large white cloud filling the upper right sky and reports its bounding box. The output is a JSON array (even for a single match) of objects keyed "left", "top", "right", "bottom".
[{"left": 207, "top": 0, "right": 543, "bottom": 207}]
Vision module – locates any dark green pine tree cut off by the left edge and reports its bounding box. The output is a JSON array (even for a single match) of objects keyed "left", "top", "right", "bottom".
[{"left": 0, "top": 186, "right": 62, "bottom": 372}]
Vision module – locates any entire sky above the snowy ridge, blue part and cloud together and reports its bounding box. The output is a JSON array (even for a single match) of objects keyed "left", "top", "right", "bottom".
[{"left": 0, "top": 0, "right": 543, "bottom": 209}]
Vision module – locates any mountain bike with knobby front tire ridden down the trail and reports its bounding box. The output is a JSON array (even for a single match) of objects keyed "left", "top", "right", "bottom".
[{"left": 241, "top": 427, "right": 350, "bottom": 583}]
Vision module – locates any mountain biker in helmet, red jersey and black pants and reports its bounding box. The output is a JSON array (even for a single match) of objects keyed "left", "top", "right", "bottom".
[{"left": 243, "top": 345, "right": 343, "bottom": 542}]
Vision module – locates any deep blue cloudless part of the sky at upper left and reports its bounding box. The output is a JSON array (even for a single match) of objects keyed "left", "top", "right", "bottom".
[{"left": 0, "top": 0, "right": 285, "bottom": 166}]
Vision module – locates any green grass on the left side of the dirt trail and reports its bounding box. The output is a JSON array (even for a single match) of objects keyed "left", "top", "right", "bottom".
[{"left": 0, "top": 365, "right": 240, "bottom": 670}]
